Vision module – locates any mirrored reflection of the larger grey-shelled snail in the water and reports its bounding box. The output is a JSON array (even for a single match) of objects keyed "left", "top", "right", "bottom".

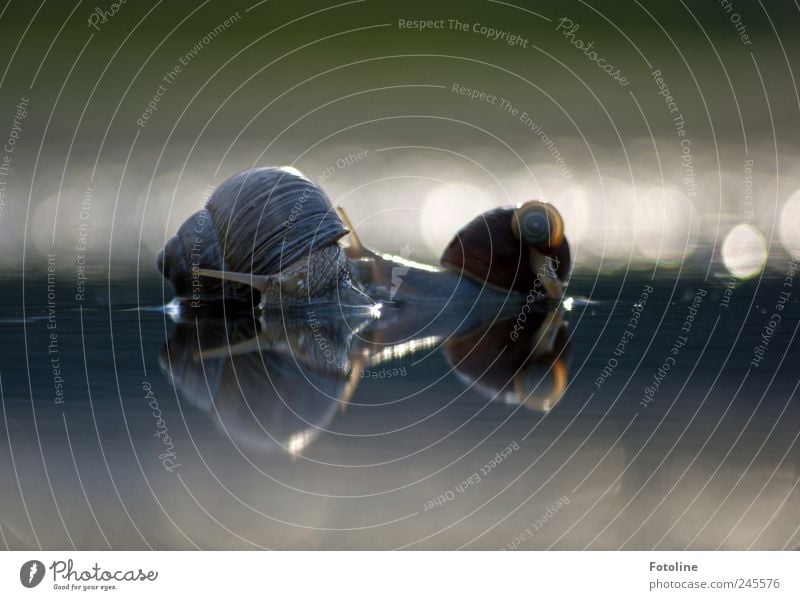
[{"left": 160, "top": 316, "right": 371, "bottom": 454}]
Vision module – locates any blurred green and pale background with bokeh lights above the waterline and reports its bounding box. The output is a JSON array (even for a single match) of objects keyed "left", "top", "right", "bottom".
[{"left": 0, "top": 0, "right": 800, "bottom": 279}]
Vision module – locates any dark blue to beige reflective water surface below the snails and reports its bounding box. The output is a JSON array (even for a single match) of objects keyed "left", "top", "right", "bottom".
[{"left": 0, "top": 272, "right": 800, "bottom": 549}]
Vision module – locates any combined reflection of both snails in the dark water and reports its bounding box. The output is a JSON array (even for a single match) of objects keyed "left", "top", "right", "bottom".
[{"left": 160, "top": 300, "right": 570, "bottom": 455}]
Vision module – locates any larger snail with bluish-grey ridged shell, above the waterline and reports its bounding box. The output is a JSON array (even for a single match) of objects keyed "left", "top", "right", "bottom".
[{"left": 157, "top": 167, "right": 348, "bottom": 306}]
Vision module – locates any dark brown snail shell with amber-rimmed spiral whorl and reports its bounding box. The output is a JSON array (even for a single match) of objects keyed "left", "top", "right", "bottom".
[{"left": 440, "top": 200, "right": 571, "bottom": 298}]
